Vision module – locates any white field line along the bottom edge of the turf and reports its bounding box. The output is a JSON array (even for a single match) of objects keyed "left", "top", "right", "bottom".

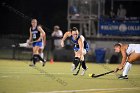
[{"left": 29, "top": 87, "right": 140, "bottom": 93}]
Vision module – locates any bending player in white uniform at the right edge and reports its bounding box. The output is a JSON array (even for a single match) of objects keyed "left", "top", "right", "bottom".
[{"left": 114, "top": 43, "right": 140, "bottom": 79}]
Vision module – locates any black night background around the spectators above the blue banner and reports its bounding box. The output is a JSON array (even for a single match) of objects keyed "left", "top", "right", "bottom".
[{"left": 105, "top": 0, "right": 140, "bottom": 17}]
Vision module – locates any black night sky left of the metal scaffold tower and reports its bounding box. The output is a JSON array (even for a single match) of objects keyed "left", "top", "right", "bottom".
[{"left": 0, "top": 0, "right": 67, "bottom": 35}]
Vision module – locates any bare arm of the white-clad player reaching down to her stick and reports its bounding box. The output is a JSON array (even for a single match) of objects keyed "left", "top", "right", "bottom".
[{"left": 119, "top": 47, "right": 127, "bottom": 70}]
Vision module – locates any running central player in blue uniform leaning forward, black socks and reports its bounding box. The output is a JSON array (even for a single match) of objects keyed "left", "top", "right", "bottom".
[{"left": 61, "top": 27, "right": 89, "bottom": 75}]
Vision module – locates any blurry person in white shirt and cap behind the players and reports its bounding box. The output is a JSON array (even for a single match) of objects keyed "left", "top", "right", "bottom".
[{"left": 52, "top": 25, "right": 63, "bottom": 49}]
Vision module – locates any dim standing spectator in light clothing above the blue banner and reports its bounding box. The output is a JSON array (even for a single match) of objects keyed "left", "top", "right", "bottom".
[{"left": 117, "top": 4, "right": 127, "bottom": 19}]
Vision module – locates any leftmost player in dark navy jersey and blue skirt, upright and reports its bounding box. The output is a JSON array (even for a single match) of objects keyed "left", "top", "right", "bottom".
[{"left": 29, "top": 19, "right": 45, "bottom": 66}]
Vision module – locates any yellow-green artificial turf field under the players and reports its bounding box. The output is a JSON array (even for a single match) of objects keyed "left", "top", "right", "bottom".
[{"left": 0, "top": 60, "right": 140, "bottom": 93}]
